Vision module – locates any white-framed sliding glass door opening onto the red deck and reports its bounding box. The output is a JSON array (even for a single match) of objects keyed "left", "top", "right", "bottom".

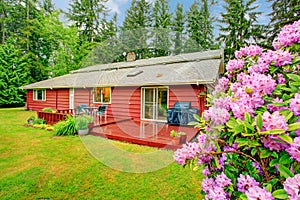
[{"left": 142, "top": 87, "right": 168, "bottom": 121}]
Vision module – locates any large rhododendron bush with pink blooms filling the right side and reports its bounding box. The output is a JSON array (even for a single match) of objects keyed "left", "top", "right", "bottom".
[{"left": 174, "top": 21, "right": 300, "bottom": 200}]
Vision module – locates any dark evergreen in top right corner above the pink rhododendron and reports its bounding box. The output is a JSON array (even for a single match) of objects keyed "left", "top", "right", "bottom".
[{"left": 267, "top": 0, "right": 300, "bottom": 46}]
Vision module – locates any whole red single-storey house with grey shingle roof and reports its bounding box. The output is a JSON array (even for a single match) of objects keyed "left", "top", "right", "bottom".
[{"left": 22, "top": 50, "right": 223, "bottom": 122}]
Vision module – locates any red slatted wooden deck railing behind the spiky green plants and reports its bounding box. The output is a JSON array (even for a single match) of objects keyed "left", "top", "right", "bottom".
[{"left": 37, "top": 109, "right": 74, "bottom": 125}]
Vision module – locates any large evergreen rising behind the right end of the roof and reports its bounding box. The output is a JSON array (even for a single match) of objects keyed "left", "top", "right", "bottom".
[{"left": 217, "top": 0, "right": 263, "bottom": 60}]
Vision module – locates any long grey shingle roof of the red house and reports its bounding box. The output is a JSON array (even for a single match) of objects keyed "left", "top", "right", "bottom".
[{"left": 22, "top": 50, "right": 223, "bottom": 89}]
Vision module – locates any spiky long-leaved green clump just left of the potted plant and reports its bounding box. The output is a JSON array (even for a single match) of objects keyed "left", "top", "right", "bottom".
[{"left": 54, "top": 115, "right": 76, "bottom": 136}]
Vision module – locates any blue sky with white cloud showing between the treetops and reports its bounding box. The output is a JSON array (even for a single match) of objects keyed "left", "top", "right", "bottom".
[{"left": 52, "top": 0, "right": 271, "bottom": 25}]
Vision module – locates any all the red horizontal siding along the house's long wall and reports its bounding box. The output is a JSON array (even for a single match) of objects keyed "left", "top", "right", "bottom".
[{"left": 27, "top": 85, "right": 205, "bottom": 120}]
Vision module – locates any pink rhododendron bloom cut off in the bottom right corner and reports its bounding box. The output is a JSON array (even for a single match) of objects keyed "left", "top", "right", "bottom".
[{"left": 283, "top": 174, "right": 300, "bottom": 200}]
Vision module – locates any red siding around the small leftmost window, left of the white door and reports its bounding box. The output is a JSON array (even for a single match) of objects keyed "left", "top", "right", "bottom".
[{"left": 26, "top": 89, "right": 70, "bottom": 111}]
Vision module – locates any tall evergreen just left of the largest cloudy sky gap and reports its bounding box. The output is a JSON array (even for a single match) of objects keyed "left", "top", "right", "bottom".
[{"left": 67, "top": 0, "right": 108, "bottom": 42}]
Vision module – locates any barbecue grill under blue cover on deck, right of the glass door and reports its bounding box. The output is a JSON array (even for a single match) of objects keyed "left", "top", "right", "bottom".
[{"left": 168, "top": 102, "right": 199, "bottom": 125}]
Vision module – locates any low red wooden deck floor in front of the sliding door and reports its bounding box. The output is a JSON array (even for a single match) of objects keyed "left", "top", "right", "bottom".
[{"left": 90, "top": 116, "right": 198, "bottom": 150}]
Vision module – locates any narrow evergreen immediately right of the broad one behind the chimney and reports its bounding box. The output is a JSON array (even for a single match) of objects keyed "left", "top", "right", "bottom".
[{"left": 152, "top": 0, "right": 172, "bottom": 56}]
